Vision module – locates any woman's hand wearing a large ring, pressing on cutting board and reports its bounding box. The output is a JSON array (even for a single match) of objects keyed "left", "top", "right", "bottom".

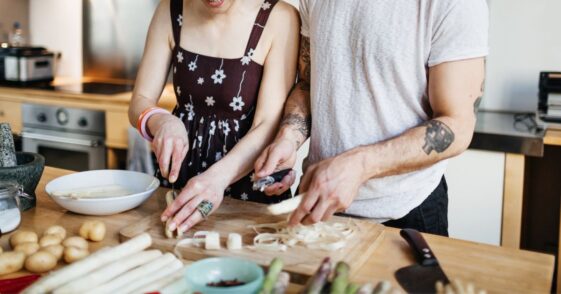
[{"left": 162, "top": 173, "right": 227, "bottom": 233}]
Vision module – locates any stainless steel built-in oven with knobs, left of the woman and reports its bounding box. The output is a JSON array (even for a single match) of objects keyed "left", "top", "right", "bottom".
[{"left": 21, "top": 104, "right": 106, "bottom": 171}]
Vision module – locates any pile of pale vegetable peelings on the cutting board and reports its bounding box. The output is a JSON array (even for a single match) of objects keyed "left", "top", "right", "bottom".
[{"left": 250, "top": 221, "right": 358, "bottom": 251}]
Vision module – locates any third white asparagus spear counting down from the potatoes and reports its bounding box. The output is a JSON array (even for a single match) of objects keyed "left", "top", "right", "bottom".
[{"left": 86, "top": 253, "right": 177, "bottom": 294}]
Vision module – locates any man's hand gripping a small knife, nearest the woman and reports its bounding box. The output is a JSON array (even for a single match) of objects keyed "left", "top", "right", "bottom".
[{"left": 255, "top": 139, "right": 298, "bottom": 196}]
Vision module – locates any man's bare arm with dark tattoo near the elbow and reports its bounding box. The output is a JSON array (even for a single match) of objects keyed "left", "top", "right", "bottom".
[{"left": 290, "top": 58, "right": 485, "bottom": 225}]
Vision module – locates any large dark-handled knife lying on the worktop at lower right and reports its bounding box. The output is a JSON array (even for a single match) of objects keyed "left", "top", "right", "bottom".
[{"left": 395, "top": 229, "right": 450, "bottom": 293}]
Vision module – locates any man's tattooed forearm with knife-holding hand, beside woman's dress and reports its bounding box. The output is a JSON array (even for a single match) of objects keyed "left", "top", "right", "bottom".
[{"left": 255, "top": 36, "right": 312, "bottom": 195}]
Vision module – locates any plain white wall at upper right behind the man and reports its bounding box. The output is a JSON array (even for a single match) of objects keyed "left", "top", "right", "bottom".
[{"left": 482, "top": 0, "right": 561, "bottom": 111}]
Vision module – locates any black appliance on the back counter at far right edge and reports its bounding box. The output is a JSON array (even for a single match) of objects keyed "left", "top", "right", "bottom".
[{"left": 538, "top": 72, "right": 561, "bottom": 122}]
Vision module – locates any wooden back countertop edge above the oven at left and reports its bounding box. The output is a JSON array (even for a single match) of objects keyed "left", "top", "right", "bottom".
[{"left": 0, "top": 78, "right": 176, "bottom": 111}]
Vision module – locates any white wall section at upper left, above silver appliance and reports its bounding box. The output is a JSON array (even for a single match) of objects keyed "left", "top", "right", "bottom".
[{"left": 29, "top": 0, "right": 82, "bottom": 78}]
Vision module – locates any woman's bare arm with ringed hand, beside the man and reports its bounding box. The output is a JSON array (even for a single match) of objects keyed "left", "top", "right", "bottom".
[{"left": 162, "top": 2, "right": 300, "bottom": 231}]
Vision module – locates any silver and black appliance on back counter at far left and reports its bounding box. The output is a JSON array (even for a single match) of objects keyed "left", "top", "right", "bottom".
[{"left": 0, "top": 45, "right": 55, "bottom": 84}]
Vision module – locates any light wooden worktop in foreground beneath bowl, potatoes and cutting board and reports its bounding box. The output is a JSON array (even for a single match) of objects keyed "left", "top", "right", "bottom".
[{"left": 0, "top": 168, "right": 554, "bottom": 293}]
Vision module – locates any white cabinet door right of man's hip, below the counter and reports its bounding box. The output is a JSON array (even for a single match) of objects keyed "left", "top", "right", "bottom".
[{"left": 446, "top": 150, "right": 505, "bottom": 245}]
